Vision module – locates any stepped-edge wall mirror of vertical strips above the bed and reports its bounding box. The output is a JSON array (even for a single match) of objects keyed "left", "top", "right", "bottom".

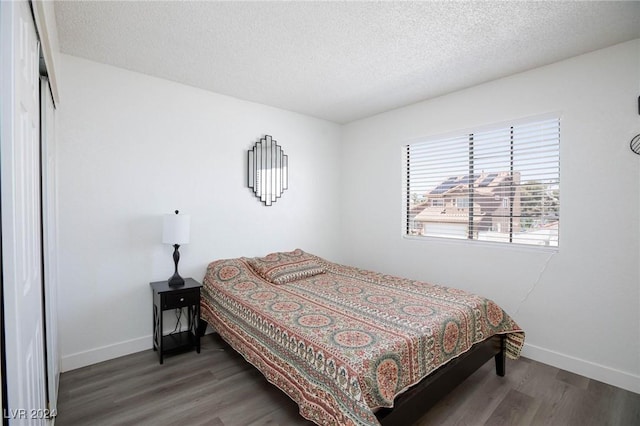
[{"left": 248, "top": 135, "right": 289, "bottom": 206}]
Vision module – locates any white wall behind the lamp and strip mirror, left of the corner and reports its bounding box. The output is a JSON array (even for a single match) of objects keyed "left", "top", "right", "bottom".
[{"left": 57, "top": 55, "right": 340, "bottom": 371}]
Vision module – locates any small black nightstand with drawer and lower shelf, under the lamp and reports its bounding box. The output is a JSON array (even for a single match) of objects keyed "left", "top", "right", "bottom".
[{"left": 149, "top": 278, "right": 202, "bottom": 364}]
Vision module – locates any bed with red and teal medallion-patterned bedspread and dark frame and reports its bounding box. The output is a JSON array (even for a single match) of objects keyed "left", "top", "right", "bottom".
[{"left": 200, "top": 249, "right": 524, "bottom": 425}]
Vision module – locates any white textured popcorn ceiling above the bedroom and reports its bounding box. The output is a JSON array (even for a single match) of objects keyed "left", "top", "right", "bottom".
[{"left": 55, "top": 1, "right": 640, "bottom": 123}]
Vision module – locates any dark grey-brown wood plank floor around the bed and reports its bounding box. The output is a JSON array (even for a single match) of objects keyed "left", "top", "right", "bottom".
[{"left": 56, "top": 335, "right": 640, "bottom": 426}]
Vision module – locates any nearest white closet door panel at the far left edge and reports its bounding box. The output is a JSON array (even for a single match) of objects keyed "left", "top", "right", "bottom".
[{"left": 0, "top": 1, "right": 47, "bottom": 425}]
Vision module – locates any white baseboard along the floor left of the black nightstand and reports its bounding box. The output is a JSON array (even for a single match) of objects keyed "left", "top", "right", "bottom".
[{"left": 60, "top": 335, "right": 153, "bottom": 373}]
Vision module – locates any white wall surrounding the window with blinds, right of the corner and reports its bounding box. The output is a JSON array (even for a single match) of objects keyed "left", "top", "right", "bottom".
[{"left": 341, "top": 40, "right": 640, "bottom": 392}]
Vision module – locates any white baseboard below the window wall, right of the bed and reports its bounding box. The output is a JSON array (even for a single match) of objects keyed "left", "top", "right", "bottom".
[{"left": 520, "top": 343, "right": 640, "bottom": 394}]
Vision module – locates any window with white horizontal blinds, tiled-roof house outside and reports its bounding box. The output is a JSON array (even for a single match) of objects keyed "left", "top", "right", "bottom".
[{"left": 404, "top": 118, "right": 560, "bottom": 247}]
